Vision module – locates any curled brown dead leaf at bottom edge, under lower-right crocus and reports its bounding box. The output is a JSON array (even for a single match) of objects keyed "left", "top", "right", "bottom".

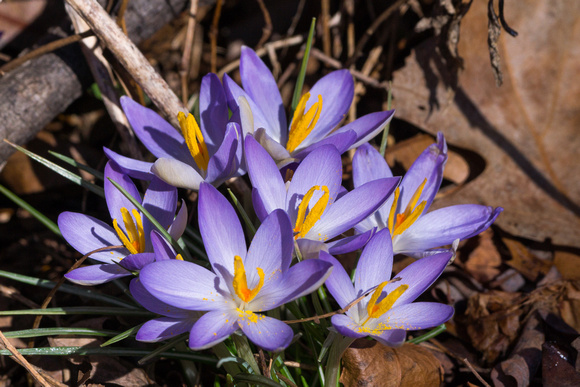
[{"left": 340, "top": 339, "right": 443, "bottom": 387}]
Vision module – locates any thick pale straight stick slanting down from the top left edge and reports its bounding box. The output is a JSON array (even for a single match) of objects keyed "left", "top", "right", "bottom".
[{"left": 67, "top": 0, "right": 185, "bottom": 128}]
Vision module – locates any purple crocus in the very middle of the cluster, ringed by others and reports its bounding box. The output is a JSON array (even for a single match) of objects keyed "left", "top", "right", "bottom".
[{"left": 244, "top": 135, "right": 399, "bottom": 257}]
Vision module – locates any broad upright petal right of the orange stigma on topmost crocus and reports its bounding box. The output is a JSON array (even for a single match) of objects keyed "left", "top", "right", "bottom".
[{"left": 301, "top": 70, "right": 354, "bottom": 147}]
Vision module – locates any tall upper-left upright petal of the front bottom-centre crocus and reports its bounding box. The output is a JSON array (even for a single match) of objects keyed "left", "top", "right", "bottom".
[{"left": 198, "top": 183, "right": 246, "bottom": 277}]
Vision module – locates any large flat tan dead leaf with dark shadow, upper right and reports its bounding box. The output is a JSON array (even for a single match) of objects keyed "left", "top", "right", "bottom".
[{"left": 393, "top": 0, "right": 580, "bottom": 246}]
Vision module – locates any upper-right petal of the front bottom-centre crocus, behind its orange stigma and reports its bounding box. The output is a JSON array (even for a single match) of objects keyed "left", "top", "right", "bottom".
[{"left": 244, "top": 210, "right": 294, "bottom": 289}]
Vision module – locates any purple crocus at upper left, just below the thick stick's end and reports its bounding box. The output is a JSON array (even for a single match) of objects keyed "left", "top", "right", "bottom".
[{"left": 105, "top": 74, "right": 242, "bottom": 190}]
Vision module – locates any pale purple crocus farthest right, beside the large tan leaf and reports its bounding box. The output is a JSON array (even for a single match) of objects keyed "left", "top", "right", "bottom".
[{"left": 352, "top": 133, "right": 503, "bottom": 258}]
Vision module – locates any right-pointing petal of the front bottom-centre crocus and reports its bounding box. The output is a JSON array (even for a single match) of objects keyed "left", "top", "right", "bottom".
[{"left": 248, "top": 259, "right": 332, "bottom": 311}]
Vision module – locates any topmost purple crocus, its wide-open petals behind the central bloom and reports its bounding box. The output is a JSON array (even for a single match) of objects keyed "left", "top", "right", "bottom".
[{"left": 224, "top": 47, "right": 394, "bottom": 161}]
